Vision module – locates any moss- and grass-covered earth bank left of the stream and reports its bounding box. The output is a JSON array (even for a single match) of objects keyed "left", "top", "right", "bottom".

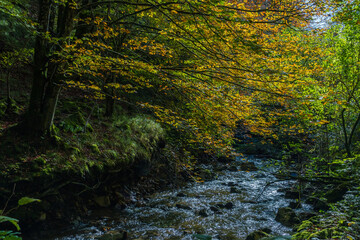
[{"left": 0, "top": 106, "right": 194, "bottom": 239}]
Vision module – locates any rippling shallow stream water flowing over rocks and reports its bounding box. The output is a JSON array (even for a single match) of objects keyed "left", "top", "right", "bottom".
[{"left": 47, "top": 157, "right": 310, "bottom": 240}]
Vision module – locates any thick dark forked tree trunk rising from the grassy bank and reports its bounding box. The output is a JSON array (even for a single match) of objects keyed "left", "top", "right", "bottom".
[{"left": 26, "top": 0, "right": 75, "bottom": 135}]
